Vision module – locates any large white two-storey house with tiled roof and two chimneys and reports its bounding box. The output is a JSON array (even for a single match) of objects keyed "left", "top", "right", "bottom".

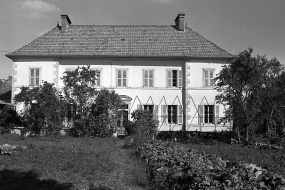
[{"left": 6, "top": 13, "right": 232, "bottom": 131}]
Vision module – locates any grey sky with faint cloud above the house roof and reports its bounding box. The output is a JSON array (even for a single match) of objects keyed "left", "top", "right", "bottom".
[{"left": 0, "top": 0, "right": 285, "bottom": 79}]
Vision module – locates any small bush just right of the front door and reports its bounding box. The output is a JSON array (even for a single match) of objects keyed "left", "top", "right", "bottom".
[{"left": 131, "top": 110, "right": 159, "bottom": 144}]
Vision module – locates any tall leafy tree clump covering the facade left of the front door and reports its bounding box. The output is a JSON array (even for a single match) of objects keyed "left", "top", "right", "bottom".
[{"left": 62, "top": 66, "right": 122, "bottom": 137}]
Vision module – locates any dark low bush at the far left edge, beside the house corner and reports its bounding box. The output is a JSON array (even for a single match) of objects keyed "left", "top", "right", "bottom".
[{"left": 0, "top": 106, "right": 22, "bottom": 133}]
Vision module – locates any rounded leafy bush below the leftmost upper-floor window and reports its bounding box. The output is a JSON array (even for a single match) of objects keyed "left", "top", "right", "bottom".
[{"left": 14, "top": 81, "right": 65, "bottom": 135}]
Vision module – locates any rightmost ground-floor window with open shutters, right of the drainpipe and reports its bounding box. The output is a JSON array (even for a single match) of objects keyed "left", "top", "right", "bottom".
[{"left": 198, "top": 105, "right": 220, "bottom": 124}]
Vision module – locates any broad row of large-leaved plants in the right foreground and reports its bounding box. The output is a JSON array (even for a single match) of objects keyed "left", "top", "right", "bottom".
[{"left": 137, "top": 141, "right": 285, "bottom": 190}]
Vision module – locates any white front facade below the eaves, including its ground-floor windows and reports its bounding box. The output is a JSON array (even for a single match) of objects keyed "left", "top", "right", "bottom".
[{"left": 12, "top": 58, "right": 230, "bottom": 131}]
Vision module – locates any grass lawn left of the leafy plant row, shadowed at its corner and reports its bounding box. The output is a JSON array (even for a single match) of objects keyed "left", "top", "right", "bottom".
[{"left": 0, "top": 135, "right": 147, "bottom": 190}]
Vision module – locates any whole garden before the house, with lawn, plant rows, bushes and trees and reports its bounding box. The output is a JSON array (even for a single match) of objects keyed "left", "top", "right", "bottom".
[{"left": 0, "top": 49, "right": 285, "bottom": 190}]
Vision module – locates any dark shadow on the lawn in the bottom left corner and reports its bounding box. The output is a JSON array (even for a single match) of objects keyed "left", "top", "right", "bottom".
[{"left": 0, "top": 169, "right": 73, "bottom": 190}]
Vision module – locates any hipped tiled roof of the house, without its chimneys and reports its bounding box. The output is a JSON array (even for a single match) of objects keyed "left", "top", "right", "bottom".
[{"left": 6, "top": 25, "right": 231, "bottom": 58}]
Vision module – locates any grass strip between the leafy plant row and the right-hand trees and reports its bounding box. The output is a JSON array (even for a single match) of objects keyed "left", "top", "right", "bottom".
[{"left": 180, "top": 141, "right": 285, "bottom": 177}]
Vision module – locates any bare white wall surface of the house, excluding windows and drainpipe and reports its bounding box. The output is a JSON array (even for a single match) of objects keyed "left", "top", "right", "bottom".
[{"left": 13, "top": 59, "right": 231, "bottom": 131}]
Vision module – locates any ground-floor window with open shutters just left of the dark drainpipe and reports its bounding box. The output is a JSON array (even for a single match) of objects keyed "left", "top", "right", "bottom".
[{"left": 161, "top": 105, "right": 183, "bottom": 124}]
